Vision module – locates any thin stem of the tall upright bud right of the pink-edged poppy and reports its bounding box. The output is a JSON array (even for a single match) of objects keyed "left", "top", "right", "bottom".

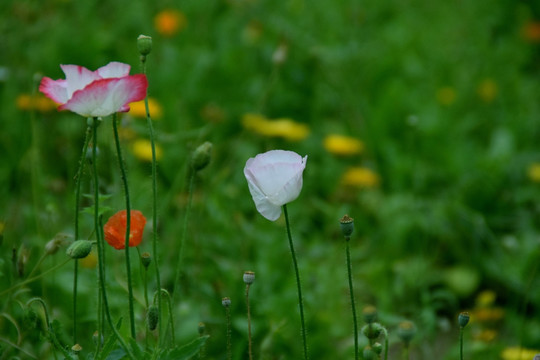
[{"left": 141, "top": 56, "right": 162, "bottom": 341}]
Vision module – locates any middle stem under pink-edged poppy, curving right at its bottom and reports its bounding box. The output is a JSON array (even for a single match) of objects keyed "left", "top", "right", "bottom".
[{"left": 92, "top": 118, "right": 135, "bottom": 359}]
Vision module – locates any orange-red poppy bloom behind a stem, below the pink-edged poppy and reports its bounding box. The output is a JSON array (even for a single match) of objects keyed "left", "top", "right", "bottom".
[{"left": 103, "top": 210, "right": 146, "bottom": 250}]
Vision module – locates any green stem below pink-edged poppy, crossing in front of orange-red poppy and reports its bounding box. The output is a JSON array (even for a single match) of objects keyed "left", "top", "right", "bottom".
[{"left": 112, "top": 113, "right": 135, "bottom": 339}]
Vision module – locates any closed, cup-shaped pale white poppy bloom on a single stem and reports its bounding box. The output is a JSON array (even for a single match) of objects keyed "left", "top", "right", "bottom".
[{"left": 244, "top": 150, "right": 307, "bottom": 221}]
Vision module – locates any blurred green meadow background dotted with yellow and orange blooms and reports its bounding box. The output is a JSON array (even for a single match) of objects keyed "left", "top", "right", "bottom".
[{"left": 0, "top": 0, "right": 540, "bottom": 359}]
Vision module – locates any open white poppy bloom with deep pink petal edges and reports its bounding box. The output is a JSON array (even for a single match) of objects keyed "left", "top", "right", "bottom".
[{"left": 39, "top": 62, "right": 148, "bottom": 117}]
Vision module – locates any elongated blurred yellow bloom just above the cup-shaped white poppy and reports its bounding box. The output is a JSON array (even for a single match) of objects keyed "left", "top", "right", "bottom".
[{"left": 242, "top": 114, "right": 309, "bottom": 141}]
